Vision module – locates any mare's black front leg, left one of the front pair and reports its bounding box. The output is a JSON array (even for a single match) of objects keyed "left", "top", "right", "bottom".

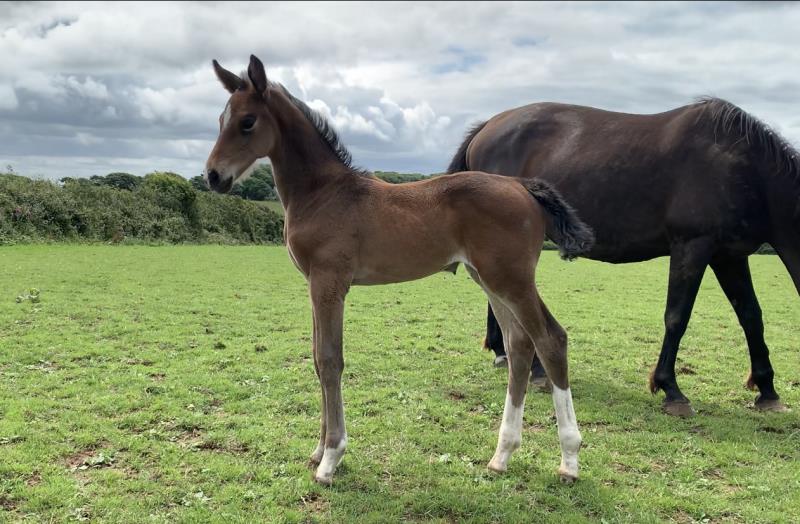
[{"left": 650, "top": 238, "right": 713, "bottom": 416}]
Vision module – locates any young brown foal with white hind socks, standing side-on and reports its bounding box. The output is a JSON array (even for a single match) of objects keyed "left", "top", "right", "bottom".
[{"left": 206, "top": 56, "right": 592, "bottom": 484}]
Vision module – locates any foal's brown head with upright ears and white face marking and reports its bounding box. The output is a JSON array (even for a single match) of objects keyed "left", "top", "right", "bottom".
[{"left": 205, "top": 55, "right": 277, "bottom": 193}]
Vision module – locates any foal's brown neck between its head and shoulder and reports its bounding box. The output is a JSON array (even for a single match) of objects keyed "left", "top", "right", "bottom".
[{"left": 269, "top": 91, "right": 350, "bottom": 213}]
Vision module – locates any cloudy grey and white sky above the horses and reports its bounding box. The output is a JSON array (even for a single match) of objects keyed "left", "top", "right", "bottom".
[{"left": 0, "top": 2, "right": 800, "bottom": 178}]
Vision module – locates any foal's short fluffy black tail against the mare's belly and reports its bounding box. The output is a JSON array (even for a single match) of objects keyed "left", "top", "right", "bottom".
[{"left": 517, "top": 179, "right": 594, "bottom": 260}]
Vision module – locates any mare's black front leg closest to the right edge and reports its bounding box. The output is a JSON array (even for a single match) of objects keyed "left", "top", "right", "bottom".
[{"left": 711, "top": 257, "right": 786, "bottom": 411}]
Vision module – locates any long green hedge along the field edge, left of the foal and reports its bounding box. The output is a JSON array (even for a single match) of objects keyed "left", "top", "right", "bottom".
[{"left": 0, "top": 173, "right": 283, "bottom": 244}]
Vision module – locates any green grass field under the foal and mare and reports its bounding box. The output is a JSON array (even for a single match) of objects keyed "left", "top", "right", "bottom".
[{"left": 0, "top": 245, "right": 800, "bottom": 523}]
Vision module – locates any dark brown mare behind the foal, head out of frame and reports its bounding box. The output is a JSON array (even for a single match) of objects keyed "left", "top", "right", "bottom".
[{"left": 449, "top": 98, "right": 800, "bottom": 416}]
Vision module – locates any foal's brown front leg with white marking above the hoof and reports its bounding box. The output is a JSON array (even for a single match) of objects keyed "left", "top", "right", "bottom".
[{"left": 308, "top": 274, "right": 347, "bottom": 484}]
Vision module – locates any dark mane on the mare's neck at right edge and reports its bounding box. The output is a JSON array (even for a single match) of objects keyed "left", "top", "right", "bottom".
[{"left": 696, "top": 97, "right": 800, "bottom": 182}]
